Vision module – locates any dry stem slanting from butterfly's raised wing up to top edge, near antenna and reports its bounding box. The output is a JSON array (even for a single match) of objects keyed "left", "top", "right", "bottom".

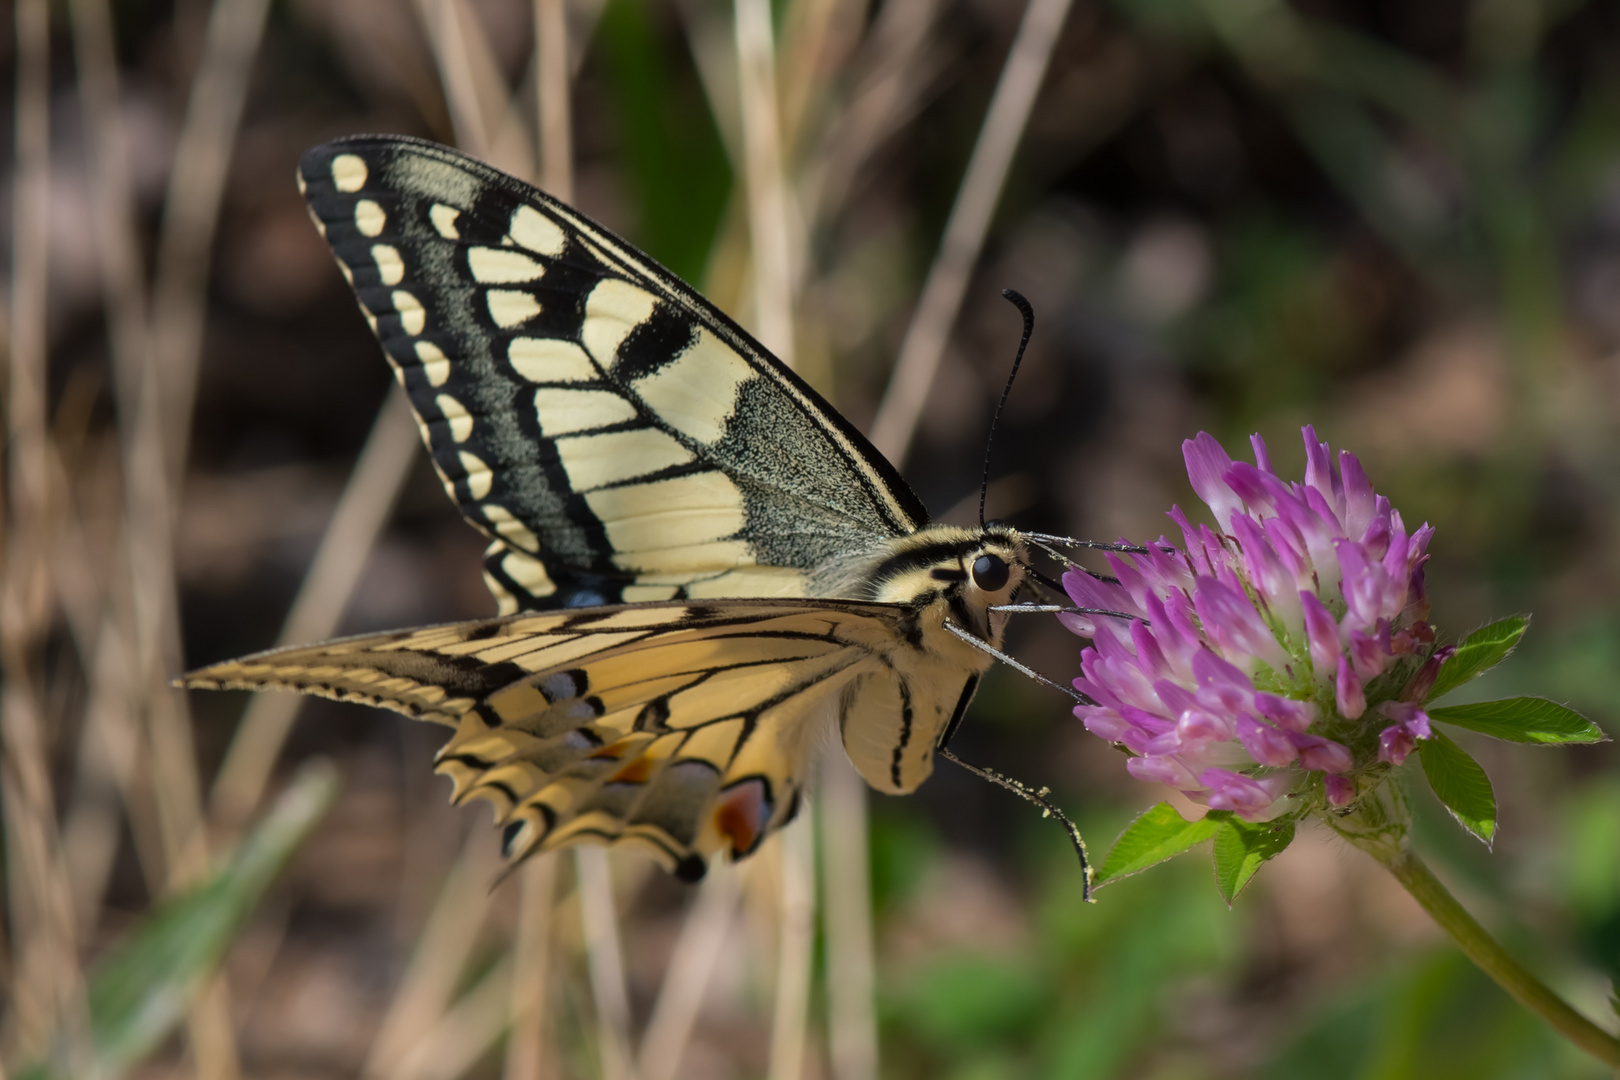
[{"left": 872, "top": 0, "right": 1071, "bottom": 465}]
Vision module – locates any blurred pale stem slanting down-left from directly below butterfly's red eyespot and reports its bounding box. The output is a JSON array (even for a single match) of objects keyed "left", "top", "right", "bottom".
[{"left": 638, "top": 863, "right": 744, "bottom": 1080}]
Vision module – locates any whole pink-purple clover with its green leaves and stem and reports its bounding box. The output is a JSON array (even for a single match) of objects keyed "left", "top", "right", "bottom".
[{"left": 1058, "top": 427, "right": 1620, "bottom": 1067}]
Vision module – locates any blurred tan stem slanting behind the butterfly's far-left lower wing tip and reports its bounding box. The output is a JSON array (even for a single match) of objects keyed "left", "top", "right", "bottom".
[{"left": 211, "top": 387, "right": 420, "bottom": 832}]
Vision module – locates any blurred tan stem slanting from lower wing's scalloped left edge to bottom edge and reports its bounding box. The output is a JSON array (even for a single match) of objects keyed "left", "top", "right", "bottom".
[{"left": 361, "top": 821, "right": 504, "bottom": 1078}]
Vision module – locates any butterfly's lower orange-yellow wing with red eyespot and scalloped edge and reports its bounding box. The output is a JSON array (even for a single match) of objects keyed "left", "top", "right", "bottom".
[{"left": 185, "top": 599, "right": 959, "bottom": 876}]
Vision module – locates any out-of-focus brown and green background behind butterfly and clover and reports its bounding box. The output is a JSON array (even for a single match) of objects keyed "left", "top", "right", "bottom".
[{"left": 0, "top": 0, "right": 1620, "bottom": 1080}]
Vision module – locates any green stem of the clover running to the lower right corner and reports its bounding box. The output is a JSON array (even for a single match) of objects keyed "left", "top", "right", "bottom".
[{"left": 1382, "top": 852, "right": 1620, "bottom": 1069}]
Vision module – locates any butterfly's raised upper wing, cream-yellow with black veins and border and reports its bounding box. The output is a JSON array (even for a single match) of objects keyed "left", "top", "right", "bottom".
[{"left": 300, "top": 136, "right": 925, "bottom": 610}]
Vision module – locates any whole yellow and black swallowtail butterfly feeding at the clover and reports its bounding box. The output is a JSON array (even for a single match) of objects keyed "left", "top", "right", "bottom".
[{"left": 185, "top": 136, "right": 1027, "bottom": 878}]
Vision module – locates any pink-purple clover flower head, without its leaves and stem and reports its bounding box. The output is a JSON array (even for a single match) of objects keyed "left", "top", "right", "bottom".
[{"left": 1059, "top": 427, "right": 1445, "bottom": 821}]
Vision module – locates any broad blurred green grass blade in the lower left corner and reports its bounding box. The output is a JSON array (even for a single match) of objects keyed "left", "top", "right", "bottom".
[{"left": 19, "top": 761, "right": 339, "bottom": 1080}]
